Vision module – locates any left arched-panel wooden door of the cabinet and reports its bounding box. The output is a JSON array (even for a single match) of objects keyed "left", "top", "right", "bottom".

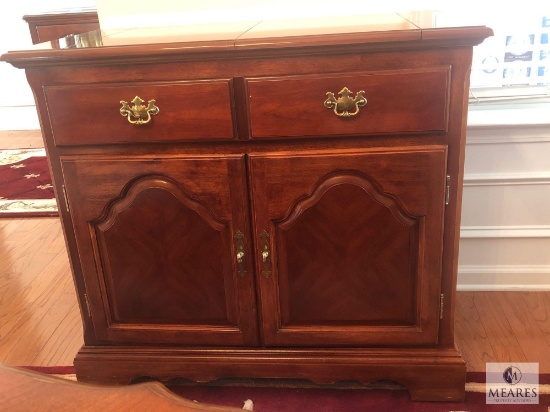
[{"left": 61, "top": 156, "right": 258, "bottom": 345}]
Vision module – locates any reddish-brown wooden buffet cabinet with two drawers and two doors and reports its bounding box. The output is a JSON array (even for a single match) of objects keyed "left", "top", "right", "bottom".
[{"left": 2, "top": 13, "right": 491, "bottom": 400}]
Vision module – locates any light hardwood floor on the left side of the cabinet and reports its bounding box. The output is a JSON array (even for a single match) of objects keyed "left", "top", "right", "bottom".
[{"left": 0, "top": 130, "right": 83, "bottom": 366}]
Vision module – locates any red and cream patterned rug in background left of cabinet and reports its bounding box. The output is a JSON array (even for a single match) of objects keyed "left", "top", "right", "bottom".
[{"left": 0, "top": 149, "right": 58, "bottom": 217}]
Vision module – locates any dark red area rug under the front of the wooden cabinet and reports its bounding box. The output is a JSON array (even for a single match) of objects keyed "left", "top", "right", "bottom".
[{"left": 19, "top": 366, "right": 550, "bottom": 412}]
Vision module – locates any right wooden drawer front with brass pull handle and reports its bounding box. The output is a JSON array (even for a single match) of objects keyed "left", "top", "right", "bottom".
[{"left": 246, "top": 67, "right": 450, "bottom": 139}]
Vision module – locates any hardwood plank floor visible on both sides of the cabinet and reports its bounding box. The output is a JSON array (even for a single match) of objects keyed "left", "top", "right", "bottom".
[{"left": 0, "top": 131, "right": 550, "bottom": 373}]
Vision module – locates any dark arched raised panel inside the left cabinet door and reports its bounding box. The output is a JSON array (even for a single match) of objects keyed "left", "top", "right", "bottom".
[{"left": 94, "top": 176, "right": 232, "bottom": 328}]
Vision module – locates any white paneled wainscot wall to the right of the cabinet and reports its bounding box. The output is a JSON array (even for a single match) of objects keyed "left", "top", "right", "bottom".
[{"left": 458, "top": 119, "right": 550, "bottom": 290}]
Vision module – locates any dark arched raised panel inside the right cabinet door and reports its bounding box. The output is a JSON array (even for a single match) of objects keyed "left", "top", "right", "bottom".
[{"left": 276, "top": 174, "right": 423, "bottom": 327}]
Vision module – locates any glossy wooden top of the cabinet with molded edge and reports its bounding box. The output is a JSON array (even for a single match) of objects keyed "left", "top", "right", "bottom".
[{"left": 0, "top": 11, "right": 492, "bottom": 67}]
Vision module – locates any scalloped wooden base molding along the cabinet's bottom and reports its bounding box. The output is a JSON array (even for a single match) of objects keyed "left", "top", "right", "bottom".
[{"left": 74, "top": 346, "right": 466, "bottom": 401}]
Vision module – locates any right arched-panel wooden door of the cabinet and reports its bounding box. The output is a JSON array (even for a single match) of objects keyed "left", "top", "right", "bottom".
[{"left": 250, "top": 146, "right": 447, "bottom": 346}]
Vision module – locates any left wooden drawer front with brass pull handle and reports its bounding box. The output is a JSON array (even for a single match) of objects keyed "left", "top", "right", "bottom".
[{"left": 44, "top": 80, "right": 235, "bottom": 146}]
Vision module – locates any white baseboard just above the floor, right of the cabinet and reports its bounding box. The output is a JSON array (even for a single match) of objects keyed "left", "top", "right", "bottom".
[{"left": 457, "top": 265, "right": 550, "bottom": 291}]
